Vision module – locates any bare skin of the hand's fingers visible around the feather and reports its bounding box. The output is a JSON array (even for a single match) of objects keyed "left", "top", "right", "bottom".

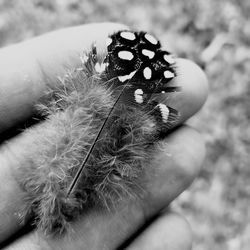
[{"left": 0, "top": 23, "right": 208, "bottom": 250}]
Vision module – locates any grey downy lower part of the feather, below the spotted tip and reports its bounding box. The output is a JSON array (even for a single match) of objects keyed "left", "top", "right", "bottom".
[{"left": 17, "top": 48, "right": 156, "bottom": 234}]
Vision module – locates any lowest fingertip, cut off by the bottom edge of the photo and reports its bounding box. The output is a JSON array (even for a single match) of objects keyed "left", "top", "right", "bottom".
[{"left": 125, "top": 213, "right": 192, "bottom": 250}]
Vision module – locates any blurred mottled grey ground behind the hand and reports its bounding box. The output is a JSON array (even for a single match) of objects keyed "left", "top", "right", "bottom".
[{"left": 0, "top": 0, "right": 250, "bottom": 250}]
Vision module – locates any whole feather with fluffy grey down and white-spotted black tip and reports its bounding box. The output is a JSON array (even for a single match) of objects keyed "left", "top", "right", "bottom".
[{"left": 15, "top": 31, "right": 179, "bottom": 235}]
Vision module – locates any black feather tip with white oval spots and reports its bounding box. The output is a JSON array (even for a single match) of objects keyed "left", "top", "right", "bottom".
[{"left": 104, "top": 30, "right": 180, "bottom": 132}]
